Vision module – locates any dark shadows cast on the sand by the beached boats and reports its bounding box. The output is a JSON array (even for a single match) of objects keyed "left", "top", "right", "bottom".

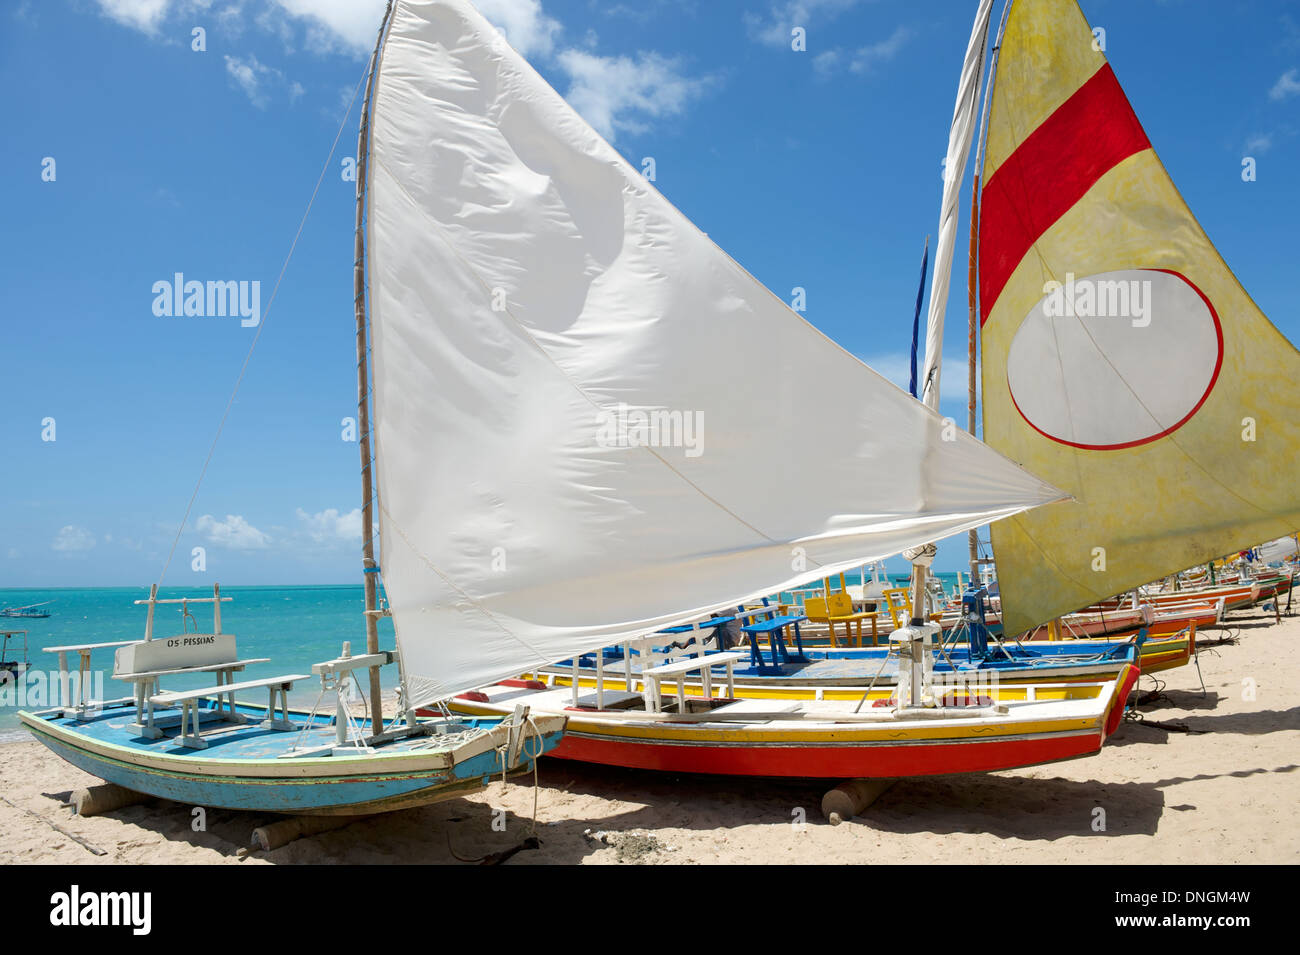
[{"left": 38, "top": 753, "right": 1300, "bottom": 865}]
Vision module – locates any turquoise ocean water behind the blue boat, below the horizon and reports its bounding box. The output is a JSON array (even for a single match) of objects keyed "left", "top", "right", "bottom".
[{"left": 0, "top": 573, "right": 957, "bottom": 742}]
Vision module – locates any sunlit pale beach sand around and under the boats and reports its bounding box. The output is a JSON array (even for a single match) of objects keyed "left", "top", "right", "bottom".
[{"left": 0, "top": 611, "right": 1300, "bottom": 865}]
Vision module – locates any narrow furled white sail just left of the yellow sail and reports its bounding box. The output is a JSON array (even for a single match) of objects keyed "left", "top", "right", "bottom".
[{"left": 918, "top": 0, "right": 993, "bottom": 409}]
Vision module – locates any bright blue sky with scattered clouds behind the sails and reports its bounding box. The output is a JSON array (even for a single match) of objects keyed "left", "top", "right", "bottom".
[{"left": 0, "top": 0, "right": 1300, "bottom": 587}]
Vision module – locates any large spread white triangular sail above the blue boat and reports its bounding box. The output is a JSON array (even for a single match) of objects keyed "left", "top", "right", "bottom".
[{"left": 368, "top": 0, "right": 1061, "bottom": 704}]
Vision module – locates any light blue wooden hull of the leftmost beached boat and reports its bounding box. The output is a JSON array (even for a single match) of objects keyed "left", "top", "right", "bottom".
[{"left": 18, "top": 707, "right": 564, "bottom": 816}]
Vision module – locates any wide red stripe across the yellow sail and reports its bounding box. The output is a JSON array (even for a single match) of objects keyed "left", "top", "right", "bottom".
[{"left": 979, "top": 64, "right": 1151, "bottom": 325}]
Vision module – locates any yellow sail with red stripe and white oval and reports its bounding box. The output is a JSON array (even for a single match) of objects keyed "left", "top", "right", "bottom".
[{"left": 979, "top": 0, "right": 1300, "bottom": 633}]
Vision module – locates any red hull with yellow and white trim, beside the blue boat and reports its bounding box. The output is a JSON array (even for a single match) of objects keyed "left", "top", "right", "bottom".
[{"left": 452, "top": 667, "right": 1138, "bottom": 780}]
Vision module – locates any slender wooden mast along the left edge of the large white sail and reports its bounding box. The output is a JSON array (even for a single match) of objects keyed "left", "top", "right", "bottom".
[{"left": 352, "top": 0, "right": 393, "bottom": 733}]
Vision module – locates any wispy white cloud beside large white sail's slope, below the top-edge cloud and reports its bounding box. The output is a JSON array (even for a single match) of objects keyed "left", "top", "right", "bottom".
[{"left": 559, "top": 49, "right": 712, "bottom": 142}]
